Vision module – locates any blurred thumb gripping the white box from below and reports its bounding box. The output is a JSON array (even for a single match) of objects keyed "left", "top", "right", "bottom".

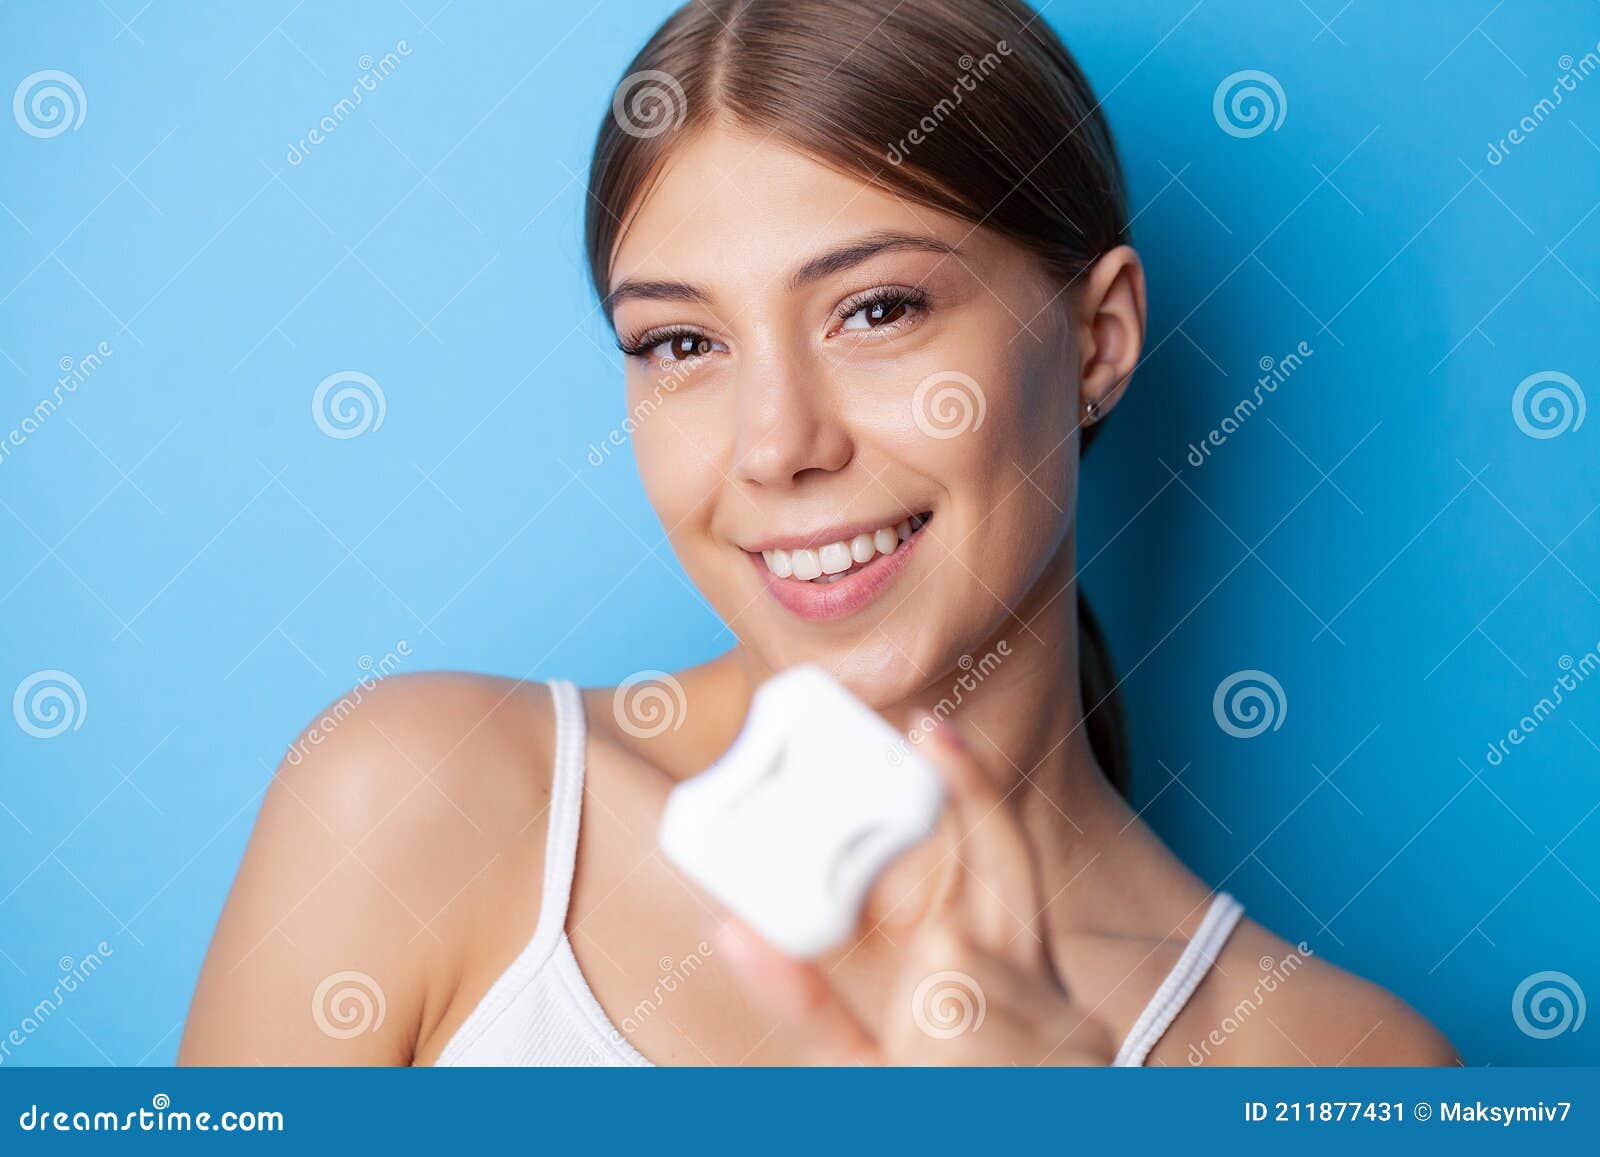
[{"left": 714, "top": 917, "right": 882, "bottom": 1064}]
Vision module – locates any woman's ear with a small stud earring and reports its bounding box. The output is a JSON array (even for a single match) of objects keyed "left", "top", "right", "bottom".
[{"left": 1075, "top": 245, "right": 1144, "bottom": 426}]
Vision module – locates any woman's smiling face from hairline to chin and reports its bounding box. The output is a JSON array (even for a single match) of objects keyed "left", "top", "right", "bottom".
[{"left": 611, "top": 128, "right": 1078, "bottom": 706}]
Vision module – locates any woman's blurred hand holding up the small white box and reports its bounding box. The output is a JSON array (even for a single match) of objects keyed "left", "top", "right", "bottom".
[{"left": 717, "top": 720, "right": 1115, "bottom": 1066}]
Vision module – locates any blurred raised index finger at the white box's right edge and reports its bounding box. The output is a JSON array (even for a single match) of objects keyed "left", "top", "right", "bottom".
[{"left": 928, "top": 720, "right": 1043, "bottom": 968}]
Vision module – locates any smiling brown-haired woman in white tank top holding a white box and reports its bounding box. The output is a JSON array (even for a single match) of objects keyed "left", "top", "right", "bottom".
[{"left": 182, "top": 0, "right": 1454, "bottom": 1064}]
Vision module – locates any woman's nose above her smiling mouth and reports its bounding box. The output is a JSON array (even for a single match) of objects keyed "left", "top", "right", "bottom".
[{"left": 733, "top": 344, "right": 854, "bottom": 488}]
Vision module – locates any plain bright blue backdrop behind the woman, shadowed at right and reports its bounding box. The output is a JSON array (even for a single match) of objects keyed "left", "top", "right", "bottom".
[{"left": 0, "top": 0, "right": 1600, "bottom": 1064}]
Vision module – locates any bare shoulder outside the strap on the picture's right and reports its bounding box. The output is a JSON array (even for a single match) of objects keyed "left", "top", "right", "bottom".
[{"left": 1177, "top": 919, "right": 1459, "bottom": 1066}]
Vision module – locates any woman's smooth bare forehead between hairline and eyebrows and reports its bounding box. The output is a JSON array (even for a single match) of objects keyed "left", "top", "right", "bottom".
[{"left": 611, "top": 125, "right": 982, "bottom": 285}]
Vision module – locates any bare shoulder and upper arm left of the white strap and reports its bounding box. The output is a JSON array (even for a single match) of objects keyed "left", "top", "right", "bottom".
[{"left": 181, "top": 674, "right": 554, "bottom": 1064}]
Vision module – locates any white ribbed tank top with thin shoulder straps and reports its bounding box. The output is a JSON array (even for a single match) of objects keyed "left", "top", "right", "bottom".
[{"left": 438, "top": 682, "right": 1243, "bottom": 1066}]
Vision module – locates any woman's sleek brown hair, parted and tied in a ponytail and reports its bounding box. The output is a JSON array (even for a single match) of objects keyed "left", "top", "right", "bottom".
[{"left": 584, "top": 0, "right": 1130, "bottom": 795}]
